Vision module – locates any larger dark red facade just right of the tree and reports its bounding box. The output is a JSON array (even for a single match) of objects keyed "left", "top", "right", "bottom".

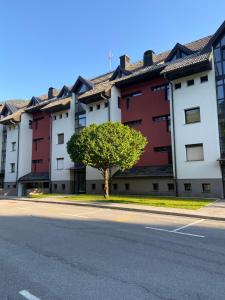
[{"left": 120, "top": 78, "right": 171, "bottom": 166}]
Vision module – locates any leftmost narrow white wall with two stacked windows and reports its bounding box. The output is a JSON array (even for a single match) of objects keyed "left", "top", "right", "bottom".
[{"left": 4, "top": 125, "right": 19, "bottom": 182}]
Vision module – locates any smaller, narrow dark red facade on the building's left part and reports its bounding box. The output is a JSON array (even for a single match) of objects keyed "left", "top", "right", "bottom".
[{"left": 32, "top": 112, "right": 51, "bottom": 173}]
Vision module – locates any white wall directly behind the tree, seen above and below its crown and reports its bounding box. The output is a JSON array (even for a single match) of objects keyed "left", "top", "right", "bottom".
[{"left": 86, "top": 86, "right": 121, "bottom": 180}]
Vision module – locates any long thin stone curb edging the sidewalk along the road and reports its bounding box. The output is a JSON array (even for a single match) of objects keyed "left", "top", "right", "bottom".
[{"left": 3, "top": 198, "right": 225, "bottom": 222}]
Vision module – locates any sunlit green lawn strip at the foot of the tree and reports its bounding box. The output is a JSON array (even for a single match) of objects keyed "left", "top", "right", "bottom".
[{"left": 31, "top": 194, "right": 214, "bottom": 210}]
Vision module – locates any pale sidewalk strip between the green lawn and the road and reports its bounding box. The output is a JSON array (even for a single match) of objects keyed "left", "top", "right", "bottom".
[{"left": 0, "top": 197, "right": 225, "bottom": 222}]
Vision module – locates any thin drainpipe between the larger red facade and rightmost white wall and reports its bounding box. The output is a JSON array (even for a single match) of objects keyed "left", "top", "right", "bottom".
[{"left": 165, "top": 75, "right": 179, "bottom": 197}]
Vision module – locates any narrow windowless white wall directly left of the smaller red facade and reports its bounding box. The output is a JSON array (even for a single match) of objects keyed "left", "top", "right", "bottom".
[{"left": 18, "top": 113, "right": 33, "bottom": 178}]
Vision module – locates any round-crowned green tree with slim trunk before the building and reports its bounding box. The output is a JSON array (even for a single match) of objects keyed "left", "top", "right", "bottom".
[{"left": 67, "top": 122, "right": 147, "bottom": 198}]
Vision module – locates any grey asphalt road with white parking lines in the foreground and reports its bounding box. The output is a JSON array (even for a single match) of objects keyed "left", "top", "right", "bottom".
[{"left": 0, "top": 200, "right": 225, "bottom": 300}]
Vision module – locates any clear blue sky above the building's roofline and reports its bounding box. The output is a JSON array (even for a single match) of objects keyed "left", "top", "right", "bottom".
[{"left": 0, "top": 0, "right": 225, "bottom": 101}]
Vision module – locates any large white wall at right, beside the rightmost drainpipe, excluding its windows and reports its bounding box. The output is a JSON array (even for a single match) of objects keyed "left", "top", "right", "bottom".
[{"left": 173, "top": 70, "right": 221, "bottom": 179}]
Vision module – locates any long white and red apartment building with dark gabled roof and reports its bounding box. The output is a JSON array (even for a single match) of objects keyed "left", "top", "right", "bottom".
[{"left": 0, "top": 23, "right": 225, "bottom": 197}]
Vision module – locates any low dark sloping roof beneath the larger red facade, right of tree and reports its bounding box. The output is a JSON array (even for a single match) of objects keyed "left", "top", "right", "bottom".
[{"left": 113, "top": 165, "right": 173, "bottom": 178}]
